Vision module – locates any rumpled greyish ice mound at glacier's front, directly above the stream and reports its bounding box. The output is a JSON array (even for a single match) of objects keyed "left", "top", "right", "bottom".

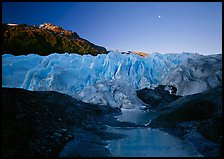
[{"left": 76, "top": 80, "right": 146, "bottom": 109}]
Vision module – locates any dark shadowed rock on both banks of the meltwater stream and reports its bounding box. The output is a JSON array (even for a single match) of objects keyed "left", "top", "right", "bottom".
[{"left": 2, "top": 86, "right": 222, "bottom": 157}]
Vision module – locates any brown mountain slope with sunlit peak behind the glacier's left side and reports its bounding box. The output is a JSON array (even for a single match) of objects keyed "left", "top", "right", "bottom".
[{"left": 2, "top": 23, "right": 107, "bottom": 56}]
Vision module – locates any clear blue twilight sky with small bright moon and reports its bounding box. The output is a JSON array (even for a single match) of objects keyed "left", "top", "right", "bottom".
[{"left": 2, "top": 2, "right": 222, "bottom": 54}]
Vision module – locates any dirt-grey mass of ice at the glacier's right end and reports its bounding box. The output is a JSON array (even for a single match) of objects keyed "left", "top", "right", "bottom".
[{"left": 161, "top": 54, "right": 222, "bottom": 95}]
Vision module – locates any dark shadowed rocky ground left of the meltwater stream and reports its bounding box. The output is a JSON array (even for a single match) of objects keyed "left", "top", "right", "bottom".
[{"left": 2, "top": 88, "right": 142, "bottom": 157}]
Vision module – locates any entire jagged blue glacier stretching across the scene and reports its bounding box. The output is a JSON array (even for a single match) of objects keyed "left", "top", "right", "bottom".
[{"left": 2, "top": 52, "right": 222, "bottom": 108}]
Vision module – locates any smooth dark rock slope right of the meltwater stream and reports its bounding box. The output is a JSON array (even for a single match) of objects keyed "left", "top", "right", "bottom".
[{"left": 149, "top": 88, "right": 222, "bottom": 157}]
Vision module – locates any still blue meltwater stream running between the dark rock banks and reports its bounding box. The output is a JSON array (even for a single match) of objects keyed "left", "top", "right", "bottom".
[{"left": 107, "top": 109, "right": 200, "bottom": 157}]
